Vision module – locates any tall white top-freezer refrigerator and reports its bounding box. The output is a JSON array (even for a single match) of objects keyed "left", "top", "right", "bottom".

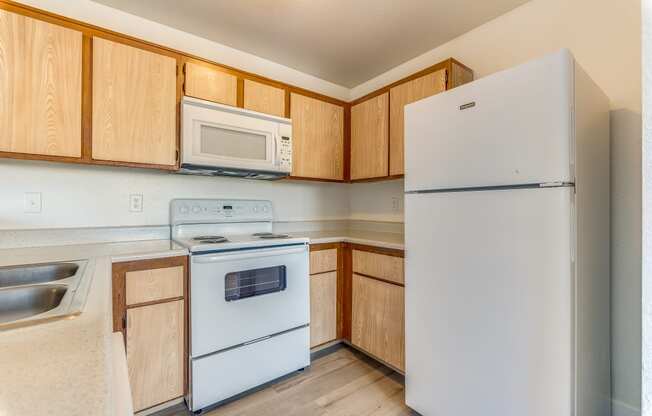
[{"left": 405, "top": 50, "right": 611, "bottom": 416}]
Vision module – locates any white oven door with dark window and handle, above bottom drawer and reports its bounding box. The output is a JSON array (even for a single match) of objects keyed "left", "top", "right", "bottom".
[{"left": 190, "top": 245, "right": 310, "bottom": 358}]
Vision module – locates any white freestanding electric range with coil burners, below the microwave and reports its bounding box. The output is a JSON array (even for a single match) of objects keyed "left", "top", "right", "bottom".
[{"left": 171, "top": 199, "right": 310, "bottom": 411}]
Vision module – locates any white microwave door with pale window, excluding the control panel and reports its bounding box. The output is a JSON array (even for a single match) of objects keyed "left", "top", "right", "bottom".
[{"left": 182, "top": 98, "right": 281, "bottom": 172}]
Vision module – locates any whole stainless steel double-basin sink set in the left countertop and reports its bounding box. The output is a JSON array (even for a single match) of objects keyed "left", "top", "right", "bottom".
[{"left": 0, "top": 260, "right": 93, "bottom": 330}]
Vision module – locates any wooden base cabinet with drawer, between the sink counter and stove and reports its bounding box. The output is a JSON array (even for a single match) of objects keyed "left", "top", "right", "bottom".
[{"left": 113, "top": 257, "right": 188, "bottom": 412}]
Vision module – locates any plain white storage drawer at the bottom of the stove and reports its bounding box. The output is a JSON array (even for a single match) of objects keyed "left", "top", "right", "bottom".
[{"left": 191, "top": 327, "right": 310, "bottom": 411}]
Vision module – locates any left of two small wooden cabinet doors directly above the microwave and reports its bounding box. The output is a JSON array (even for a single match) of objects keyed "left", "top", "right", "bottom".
[{"left": 184, "top": 62, "right": 238, "bottom": 107}]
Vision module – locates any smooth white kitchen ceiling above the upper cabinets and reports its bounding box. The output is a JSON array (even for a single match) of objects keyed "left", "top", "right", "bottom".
[{"left": 94, "top": 0, "right": 528, "bottom": 88}]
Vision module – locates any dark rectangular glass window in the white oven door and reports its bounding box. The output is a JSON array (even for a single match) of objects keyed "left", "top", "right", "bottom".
[{"left": 224, "top": 266, "right": 287, "bottom": 302}]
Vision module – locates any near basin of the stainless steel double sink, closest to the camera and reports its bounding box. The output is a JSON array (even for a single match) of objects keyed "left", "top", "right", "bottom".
[{"left": 0, "top": 285, "right": 68, "bottom": 324}]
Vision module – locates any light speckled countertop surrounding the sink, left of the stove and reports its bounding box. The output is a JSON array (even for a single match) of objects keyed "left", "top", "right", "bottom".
[{"left": 0, "top": 240, "right": 187, "bottom": 416}]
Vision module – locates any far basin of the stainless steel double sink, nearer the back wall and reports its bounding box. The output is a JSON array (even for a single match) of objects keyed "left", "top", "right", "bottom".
[{"left": 0, "top": 263, "right": 79, "bottom": 288}]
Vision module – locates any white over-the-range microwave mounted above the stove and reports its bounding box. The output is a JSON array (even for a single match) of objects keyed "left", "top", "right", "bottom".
[{"left": 180, "top": 97, "right": 292, "bottom": 180}]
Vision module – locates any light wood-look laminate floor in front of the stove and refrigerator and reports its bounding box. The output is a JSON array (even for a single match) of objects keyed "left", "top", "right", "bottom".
[{"left": 156, "top": 347, "right": 416, "bottom": 416}]
